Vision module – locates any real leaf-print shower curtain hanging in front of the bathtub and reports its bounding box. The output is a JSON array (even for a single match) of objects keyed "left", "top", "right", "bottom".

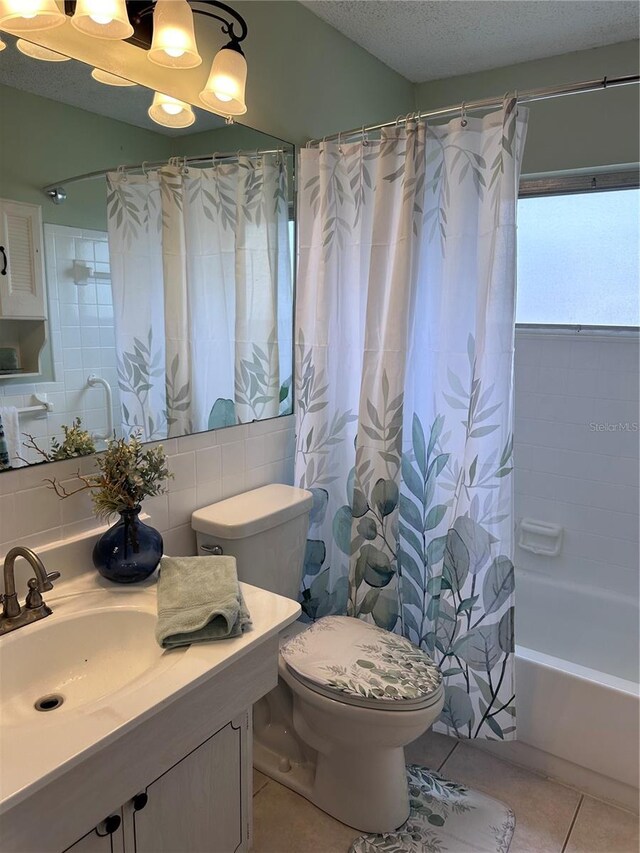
[{"left": 296, "top": 97, "right": 526, "bottom": 740}]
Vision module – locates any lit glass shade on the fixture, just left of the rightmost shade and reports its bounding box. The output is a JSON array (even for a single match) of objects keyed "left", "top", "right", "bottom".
[{"left": 147, "top": 0, "right": 202, "bottom": 68}]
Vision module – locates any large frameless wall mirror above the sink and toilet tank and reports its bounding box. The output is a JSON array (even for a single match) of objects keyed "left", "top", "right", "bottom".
[{"left": 0, "top": 33, "right": 294, "bottom": 467}]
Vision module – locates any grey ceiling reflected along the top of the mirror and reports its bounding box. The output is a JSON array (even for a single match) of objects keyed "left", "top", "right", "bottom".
[{"left": 0, "top": 33, "right": 225, "bottom": 136}]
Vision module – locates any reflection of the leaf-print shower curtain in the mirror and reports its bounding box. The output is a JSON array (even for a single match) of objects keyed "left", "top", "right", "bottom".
[{"left": 107, "top": 154, "right": 292, "bottom": 439}]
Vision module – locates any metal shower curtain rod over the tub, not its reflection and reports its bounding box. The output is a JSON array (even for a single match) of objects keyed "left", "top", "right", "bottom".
[{"left": 307, "top": 74, "right": 640, "bottom": 147}]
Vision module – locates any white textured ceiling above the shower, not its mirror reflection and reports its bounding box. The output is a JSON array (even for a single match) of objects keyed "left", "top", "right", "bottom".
[{"left": 302, "top": 0, "right": 639, "bottom": 83}]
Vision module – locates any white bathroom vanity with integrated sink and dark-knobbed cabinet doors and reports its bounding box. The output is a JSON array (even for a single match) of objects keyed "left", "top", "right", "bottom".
[{"left": 0, "top": 542, "right": 300, "bottom": 853}]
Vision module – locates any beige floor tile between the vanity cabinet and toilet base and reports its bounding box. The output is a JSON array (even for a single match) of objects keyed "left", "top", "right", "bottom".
[{"left": 252, "top": 779, "right": 360, "bottom": 853}]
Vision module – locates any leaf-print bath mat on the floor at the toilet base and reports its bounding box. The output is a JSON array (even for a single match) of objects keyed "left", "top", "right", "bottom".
[{"left": 349, "top": 764, "right": 516, "bottom": 853}]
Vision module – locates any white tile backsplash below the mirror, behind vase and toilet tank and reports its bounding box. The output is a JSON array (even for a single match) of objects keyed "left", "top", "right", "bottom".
[{"left": 0, "top": 415, "right": 294, "bottom": 559}]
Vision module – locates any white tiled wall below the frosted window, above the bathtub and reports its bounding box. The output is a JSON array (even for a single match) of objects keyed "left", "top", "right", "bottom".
[{"left": 514, "top": 330, "right": 640, "bottom": 598}]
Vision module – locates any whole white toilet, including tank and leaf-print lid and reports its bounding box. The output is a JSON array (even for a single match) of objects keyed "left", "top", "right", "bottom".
[{"left": 192, "top": 484, "right": 444, "bottom": 833}]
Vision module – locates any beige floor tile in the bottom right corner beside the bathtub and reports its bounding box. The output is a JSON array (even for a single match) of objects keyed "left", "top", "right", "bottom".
[{"left": 565, "top": 797, "right": 638, "bottom": 853}]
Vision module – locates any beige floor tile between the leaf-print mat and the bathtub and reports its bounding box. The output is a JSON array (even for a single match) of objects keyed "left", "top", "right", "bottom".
[{"left": 440, "top": 742, "right": 580, "bottom": 853}]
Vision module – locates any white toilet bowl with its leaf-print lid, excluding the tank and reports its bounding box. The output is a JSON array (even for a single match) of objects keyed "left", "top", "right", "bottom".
[{"left": 254, "top": 617, "right": 444, "bottom": 833}]
